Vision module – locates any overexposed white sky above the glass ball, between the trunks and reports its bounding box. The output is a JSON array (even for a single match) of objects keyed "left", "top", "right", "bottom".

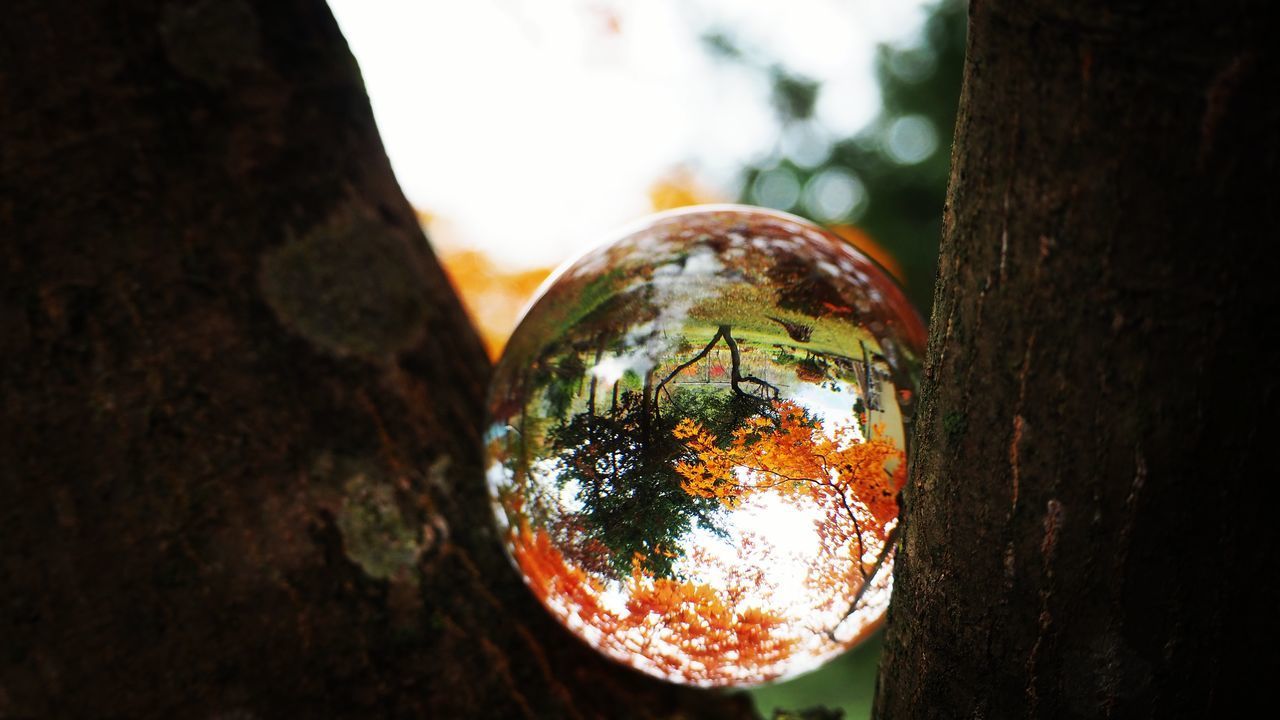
[{"left": 330, "top": 0, "right": 924, "bottom": 266}]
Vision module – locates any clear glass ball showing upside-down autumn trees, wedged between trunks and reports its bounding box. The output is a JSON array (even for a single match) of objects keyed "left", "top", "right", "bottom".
[{"left": 485, "top": 205, "right": 924, "bottom": 685}]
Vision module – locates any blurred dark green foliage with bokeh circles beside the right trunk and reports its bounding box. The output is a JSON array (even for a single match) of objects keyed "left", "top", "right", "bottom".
[{"left": 721, "top": 0, "right": 966, "bottom": 316}]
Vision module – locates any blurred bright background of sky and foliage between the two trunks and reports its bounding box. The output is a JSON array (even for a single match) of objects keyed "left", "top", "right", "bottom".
[{"left": 330, "top": 0, "right": 964, "bottom": 717}]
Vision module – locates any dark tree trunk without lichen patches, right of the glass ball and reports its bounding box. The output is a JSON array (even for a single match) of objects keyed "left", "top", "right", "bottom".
[{"left": 877, "top": 0, "right": 1280, "bottom": 720}]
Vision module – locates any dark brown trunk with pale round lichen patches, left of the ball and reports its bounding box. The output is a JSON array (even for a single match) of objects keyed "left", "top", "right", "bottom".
[{"left": 0, "top": 0, "right": 750, "bottom": 717}]
